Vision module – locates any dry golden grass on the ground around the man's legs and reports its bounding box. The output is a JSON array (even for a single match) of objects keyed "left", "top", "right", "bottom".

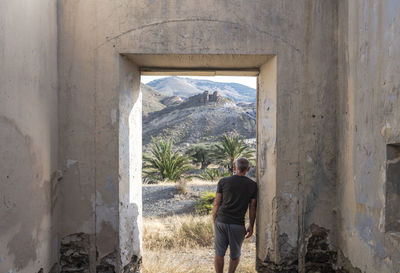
[{"left": 143, "top": 215, "right": 256, "bottom": 273}]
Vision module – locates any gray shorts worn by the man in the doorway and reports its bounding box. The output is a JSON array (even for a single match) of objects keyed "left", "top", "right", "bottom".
[{"left": 214, "top": 222, "right": 246, "bottom": 259}]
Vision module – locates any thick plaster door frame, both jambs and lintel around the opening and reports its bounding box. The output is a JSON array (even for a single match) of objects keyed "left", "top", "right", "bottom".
[{"left": 119, "top": 54, "right": 276, "bottom": 270}]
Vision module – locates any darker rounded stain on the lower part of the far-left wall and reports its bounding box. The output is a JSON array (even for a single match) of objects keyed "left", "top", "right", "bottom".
[{"left": 0, "top": 117, "right": 56, "bottom": 272}]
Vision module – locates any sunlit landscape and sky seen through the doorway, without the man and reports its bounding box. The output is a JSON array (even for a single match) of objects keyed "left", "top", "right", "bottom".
[{"left": 141, "top": 73, "right": 257, "bottom": 273}]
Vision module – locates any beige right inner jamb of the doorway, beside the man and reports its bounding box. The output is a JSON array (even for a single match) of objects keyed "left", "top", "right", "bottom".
[{"left": 256, "top": 57, "right": 279, "bottom": 266}]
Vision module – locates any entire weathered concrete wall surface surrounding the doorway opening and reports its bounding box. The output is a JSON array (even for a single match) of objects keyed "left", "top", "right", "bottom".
[{"left": 0, "top": 0, "right": 400, "bottom": 273}]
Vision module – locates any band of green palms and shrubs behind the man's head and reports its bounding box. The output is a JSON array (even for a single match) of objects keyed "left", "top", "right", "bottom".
[{"left": 143, "top": 134, "right": 255, "bottom": 183}]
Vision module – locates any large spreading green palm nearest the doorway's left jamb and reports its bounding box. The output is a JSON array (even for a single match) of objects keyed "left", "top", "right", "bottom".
[{"left": 143, "top": 138, "right": 190, "bottom": 181}]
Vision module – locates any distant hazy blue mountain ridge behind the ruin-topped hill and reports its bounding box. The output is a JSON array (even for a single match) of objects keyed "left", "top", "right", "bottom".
[{"left": 147, "top": 77, "right": 257, "bottom": 103}]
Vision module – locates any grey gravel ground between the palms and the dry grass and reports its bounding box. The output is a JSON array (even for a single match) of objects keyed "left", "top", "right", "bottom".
[{"left": 142, "top": 183, "right": 217, "bottom": 217}]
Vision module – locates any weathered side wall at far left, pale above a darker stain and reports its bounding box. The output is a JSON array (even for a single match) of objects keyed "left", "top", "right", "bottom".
[{"left": 0, "top": 0, "right": 58, "bottom": 273}]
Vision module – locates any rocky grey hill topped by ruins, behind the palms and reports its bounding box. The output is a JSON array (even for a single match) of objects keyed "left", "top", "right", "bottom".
[{"left": 143, "top": 91, "right": 256, "bottom": 145}]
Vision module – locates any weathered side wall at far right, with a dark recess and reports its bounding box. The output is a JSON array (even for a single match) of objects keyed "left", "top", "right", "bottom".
[{"left": 337, "top": 0, "right": 400, "bottom": 272}]
